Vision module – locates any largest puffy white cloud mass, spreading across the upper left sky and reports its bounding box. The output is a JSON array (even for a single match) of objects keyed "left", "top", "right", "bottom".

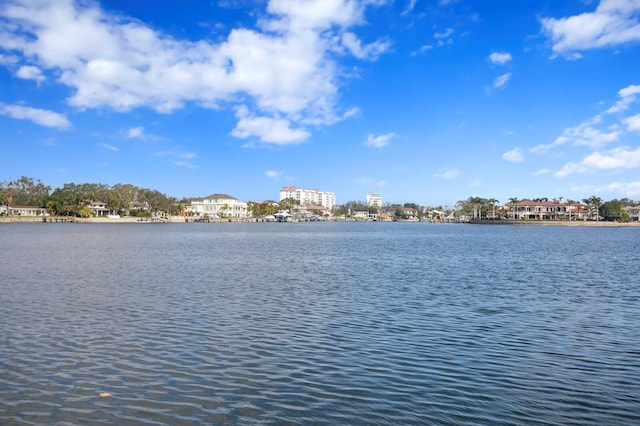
[{"left": 0, "top": 0, "right": 390, "bottom": 144}]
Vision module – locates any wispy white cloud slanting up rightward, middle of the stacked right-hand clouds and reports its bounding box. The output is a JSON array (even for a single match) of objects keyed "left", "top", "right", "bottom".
[{"left": 531, "top": 115, "right": 622, "bottom": 154}]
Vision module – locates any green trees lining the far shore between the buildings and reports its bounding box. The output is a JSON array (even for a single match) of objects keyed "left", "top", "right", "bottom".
[{"left": 0, "top": 176, "right": 640, "bottom": 222}]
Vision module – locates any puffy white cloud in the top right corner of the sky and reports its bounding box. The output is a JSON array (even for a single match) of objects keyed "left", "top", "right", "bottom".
[{"left": 542, "top": 0, "right": 640, "bottom": 55}]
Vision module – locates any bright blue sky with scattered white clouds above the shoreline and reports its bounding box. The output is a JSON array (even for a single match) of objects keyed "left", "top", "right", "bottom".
[{"left": 0, "top": 0, "right": 640, "bottom": 205}]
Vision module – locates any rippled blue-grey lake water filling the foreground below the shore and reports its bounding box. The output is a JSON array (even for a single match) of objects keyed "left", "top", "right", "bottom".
[{"left": 0, "top": 223, "right": 640, "bottom": 426}]
